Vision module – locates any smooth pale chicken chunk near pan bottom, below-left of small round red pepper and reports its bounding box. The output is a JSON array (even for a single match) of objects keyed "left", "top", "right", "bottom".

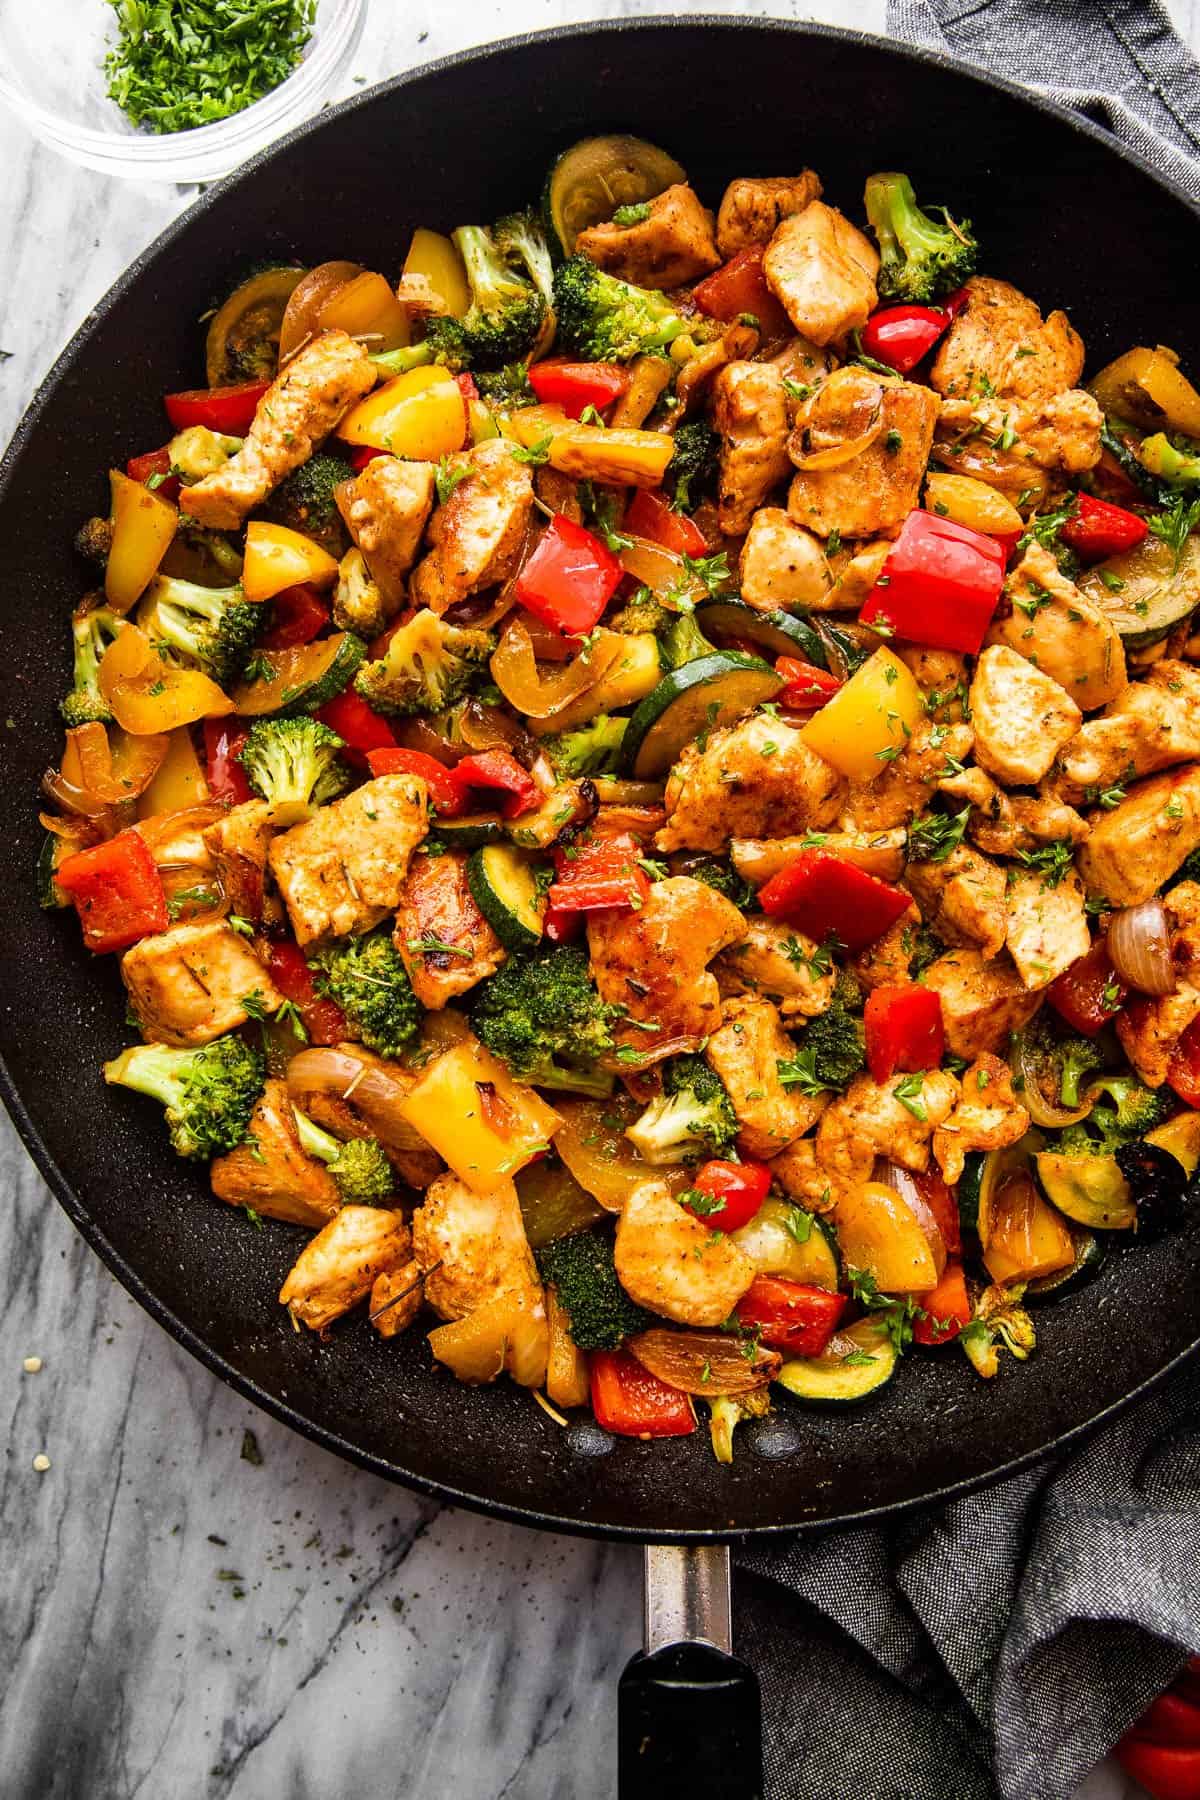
[{"left": 613, "top": 1181, "right": 756, "bottom": 1325}]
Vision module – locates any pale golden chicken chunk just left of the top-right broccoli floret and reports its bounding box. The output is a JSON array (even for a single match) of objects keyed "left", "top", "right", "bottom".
[{"left": 763, "top": 200, "right": 880, "bottom": 344}]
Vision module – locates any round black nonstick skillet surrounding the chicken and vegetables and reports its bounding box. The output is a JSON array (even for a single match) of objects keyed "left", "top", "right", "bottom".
[{"left": 0, "top": 20, "right": 1200, "bottom": 1793}]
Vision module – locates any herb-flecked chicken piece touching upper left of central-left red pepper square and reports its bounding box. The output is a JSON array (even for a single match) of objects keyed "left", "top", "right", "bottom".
[{"left": 410, "top": 437, "right": 533, "bottom": 614}]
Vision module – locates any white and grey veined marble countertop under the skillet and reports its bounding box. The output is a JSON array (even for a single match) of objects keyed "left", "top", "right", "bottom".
[{"left": 0, "top": 0, "right": 1200, "bottom": 1800}]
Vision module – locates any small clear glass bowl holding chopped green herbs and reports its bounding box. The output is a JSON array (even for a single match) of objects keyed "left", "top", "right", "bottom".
[{"left": 0, "top": 0, "right": 367, "bottom": 182}]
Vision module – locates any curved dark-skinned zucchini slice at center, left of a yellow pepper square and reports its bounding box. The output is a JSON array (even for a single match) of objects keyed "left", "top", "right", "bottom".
[{"left": 621, "top": 650, "right": 783, "bottom": 781}]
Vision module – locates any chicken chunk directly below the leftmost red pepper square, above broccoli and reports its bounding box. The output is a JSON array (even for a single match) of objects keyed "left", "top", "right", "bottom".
[{"left": 121, "top": 918, "right": 282, "bottom": 1046}]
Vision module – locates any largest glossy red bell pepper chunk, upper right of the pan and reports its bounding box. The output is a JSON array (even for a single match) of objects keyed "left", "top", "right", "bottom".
[{"left": 858, "top": 511, "right": 1006, "bottom": 655}]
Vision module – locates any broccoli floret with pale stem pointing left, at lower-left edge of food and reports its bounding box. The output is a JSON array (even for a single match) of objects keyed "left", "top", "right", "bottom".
[{"left": 104, "top": 1037, "right": 266, "bottom": 1157}]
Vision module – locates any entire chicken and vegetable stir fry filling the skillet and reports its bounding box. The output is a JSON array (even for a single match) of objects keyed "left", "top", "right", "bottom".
[{"left": 38, "top": 139, "right": 1200, "bottom": 1460}]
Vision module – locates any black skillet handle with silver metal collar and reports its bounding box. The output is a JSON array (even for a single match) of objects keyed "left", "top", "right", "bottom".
[{"left": 617, "top": 1544, "right": 763, "bottom": 1800}]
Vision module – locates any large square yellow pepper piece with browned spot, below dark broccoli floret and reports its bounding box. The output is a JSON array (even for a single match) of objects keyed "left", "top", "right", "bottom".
[{"left": 399, "top": 1039, "right": 561, "bottom": 1193}]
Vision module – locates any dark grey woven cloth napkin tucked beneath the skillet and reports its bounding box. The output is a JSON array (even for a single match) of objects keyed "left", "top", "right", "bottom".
[{"left": 734, "top": 0, "right": 1200, "bottom": 1800}]
